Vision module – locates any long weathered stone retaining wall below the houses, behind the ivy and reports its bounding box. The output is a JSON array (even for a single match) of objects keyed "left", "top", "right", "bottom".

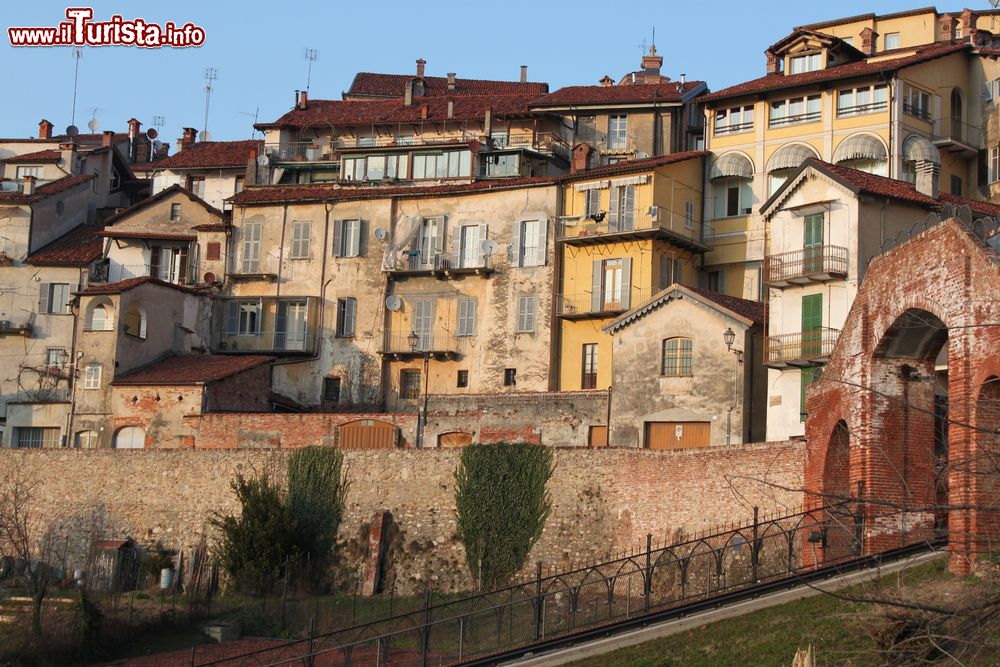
[{"left": 0, "top": 442, "right": 804, "bottom": 593}]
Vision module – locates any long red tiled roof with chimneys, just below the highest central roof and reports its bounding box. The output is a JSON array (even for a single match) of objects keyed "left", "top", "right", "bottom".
[{"left": 260, "top": 95, "right": 538, "bottom": 129}]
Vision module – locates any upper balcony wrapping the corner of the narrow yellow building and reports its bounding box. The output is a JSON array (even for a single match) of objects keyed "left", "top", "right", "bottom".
[{"left": 556, "top": 206, "right": 714, "bottom": 252}]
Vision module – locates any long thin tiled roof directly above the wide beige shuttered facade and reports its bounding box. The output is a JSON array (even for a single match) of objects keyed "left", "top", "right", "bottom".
[{"left": 228, "top": 176, "right": 560, "bottom": 206}]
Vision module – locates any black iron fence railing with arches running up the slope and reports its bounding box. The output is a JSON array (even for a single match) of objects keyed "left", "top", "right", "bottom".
[{"left": 190, "top": 503, "right": 864, "bottom": 667}]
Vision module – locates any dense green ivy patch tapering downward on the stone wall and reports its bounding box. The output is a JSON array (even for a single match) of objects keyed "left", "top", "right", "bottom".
[{"left": 455, "top": 443, "right": 553, "bottom": 588}]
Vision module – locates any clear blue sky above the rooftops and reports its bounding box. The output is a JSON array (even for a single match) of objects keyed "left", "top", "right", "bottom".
[{"left": 0, "top": 0, "right": 936, "bottom": 143}]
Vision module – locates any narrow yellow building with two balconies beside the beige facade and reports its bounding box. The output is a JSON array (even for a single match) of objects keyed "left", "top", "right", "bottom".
[{"left": 555, "top": 151, "right": 712, "bottom": 391}]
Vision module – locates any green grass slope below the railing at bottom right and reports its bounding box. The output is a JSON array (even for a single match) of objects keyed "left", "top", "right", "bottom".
[{"left": 572, "top": 560, "right": 996, "bottom": 667}]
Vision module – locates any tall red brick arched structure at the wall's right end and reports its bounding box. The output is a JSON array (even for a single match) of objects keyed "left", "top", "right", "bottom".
[{"left": 804, "top": 219, "right": 1000, "bottom": 572}]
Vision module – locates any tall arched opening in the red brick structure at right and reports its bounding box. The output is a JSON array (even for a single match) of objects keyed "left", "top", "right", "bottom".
[{"left": 865, "top": 308, "right": 950, "bottom": 551}]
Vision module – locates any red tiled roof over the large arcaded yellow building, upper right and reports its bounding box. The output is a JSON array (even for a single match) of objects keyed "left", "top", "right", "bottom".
[{"left": 699, "top": 43, "right": 972, "bottom": 102}]
